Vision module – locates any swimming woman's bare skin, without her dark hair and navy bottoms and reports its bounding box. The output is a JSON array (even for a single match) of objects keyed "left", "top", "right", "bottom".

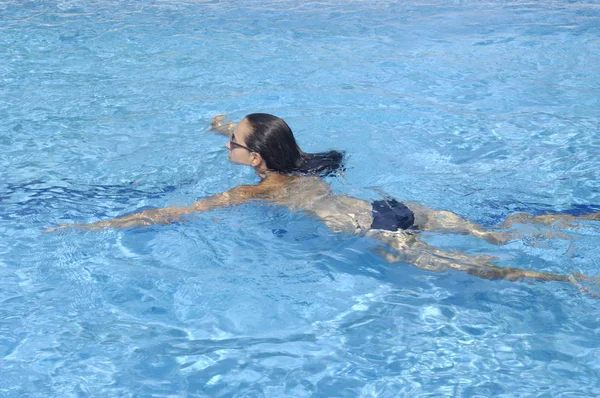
[{"left": 46, "top": 115, "right": 600, "bottom": 286}]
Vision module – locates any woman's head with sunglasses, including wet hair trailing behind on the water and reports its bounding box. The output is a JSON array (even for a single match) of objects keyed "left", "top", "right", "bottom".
[{"left": 227, "top": 113, "right": 343, "bottom": 176}]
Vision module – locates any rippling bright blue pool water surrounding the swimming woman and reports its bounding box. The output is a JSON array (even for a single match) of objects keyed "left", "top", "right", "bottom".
[{"left": 0, "top": 0, "right": 600, "bottom": 397}]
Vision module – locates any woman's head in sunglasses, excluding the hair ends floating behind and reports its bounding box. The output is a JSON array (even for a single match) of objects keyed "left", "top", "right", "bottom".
[{"left": 227, "top": 113, "right": 304, "bottom": 173}]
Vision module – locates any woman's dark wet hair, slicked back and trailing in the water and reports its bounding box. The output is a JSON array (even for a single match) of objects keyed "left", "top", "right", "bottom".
[{"left": 245, "top": 113, "right": 344, "bottom": 177}]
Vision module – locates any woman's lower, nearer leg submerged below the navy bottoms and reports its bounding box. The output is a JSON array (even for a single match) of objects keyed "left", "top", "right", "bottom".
[{"left": 372, "top": 232, "right": 575, "bottom": 283}]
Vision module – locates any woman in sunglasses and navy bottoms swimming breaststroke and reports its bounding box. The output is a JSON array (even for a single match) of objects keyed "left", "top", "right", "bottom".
[{"left": 46, "top": 113, "right": 600, "bottom": 286}]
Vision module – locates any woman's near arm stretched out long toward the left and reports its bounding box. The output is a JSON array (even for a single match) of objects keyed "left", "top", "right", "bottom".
[{"left": 42, "top": 184, "right": 270, "bottom": 232}]
